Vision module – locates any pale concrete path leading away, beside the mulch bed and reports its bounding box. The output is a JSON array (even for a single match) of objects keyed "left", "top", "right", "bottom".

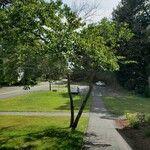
[{"left": 83, "top": 86, "right": 131, "bottom": 150}]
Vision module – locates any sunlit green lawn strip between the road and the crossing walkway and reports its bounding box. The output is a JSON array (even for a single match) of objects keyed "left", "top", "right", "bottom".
[{"left": 0, "top": 91, "right": 90, "bottom": 112}]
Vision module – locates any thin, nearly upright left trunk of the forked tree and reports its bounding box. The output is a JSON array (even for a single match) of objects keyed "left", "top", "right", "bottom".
[{"left": 67, "top": 73, "right": 74, "bottom": 127}]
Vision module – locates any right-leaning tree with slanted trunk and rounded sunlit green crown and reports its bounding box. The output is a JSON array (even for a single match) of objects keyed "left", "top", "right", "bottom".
[{"left": 70, "top": 19, "right": 132, "bottom": 129}]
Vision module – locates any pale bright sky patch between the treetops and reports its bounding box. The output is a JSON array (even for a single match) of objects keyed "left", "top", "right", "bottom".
[{"left": 63, "top": 0, "right": 121, "bottom": 22}]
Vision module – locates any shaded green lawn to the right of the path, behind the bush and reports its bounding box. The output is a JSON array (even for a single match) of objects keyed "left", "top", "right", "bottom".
[{"left": 103, "top": 95, "right": 150, "bottom": 115}]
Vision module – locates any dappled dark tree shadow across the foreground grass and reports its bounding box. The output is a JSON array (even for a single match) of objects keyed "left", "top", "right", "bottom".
[{"left": 0, "top": 127, "right": 84, "bottom": 150}]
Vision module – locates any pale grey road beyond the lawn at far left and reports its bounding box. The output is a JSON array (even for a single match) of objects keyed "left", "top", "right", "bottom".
[{"left": 0, "top": 82, "right": 49, "bottom": 100}]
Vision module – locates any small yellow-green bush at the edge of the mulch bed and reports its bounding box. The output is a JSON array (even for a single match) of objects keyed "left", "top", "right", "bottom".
[{"left": 126, "top": 113, "right": 145, "bottom": 129}]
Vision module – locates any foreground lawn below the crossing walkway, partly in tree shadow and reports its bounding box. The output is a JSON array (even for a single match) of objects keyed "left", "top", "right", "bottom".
[{"left": 0, "top": 116, "right": 88, "bottom": 150}]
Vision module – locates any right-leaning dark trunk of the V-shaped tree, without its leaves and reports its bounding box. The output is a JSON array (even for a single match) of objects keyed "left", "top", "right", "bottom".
[{"left": 72, "top": 73, "right": 95, "bottom": 130}]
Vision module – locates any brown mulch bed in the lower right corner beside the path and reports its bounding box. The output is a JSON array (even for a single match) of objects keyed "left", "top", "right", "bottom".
[{"left": 116, "top": 119, "right": 150, "bottom": 150}]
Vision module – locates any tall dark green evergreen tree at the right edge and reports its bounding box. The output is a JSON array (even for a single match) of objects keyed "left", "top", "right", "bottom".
[{"left": 113, "top": 0, "right": 150, "bottom": 93}]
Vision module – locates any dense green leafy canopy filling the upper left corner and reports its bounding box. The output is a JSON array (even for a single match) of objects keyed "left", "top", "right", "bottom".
[{"left": 0, "top": 0, "right": 82, "bottom": 127}]
